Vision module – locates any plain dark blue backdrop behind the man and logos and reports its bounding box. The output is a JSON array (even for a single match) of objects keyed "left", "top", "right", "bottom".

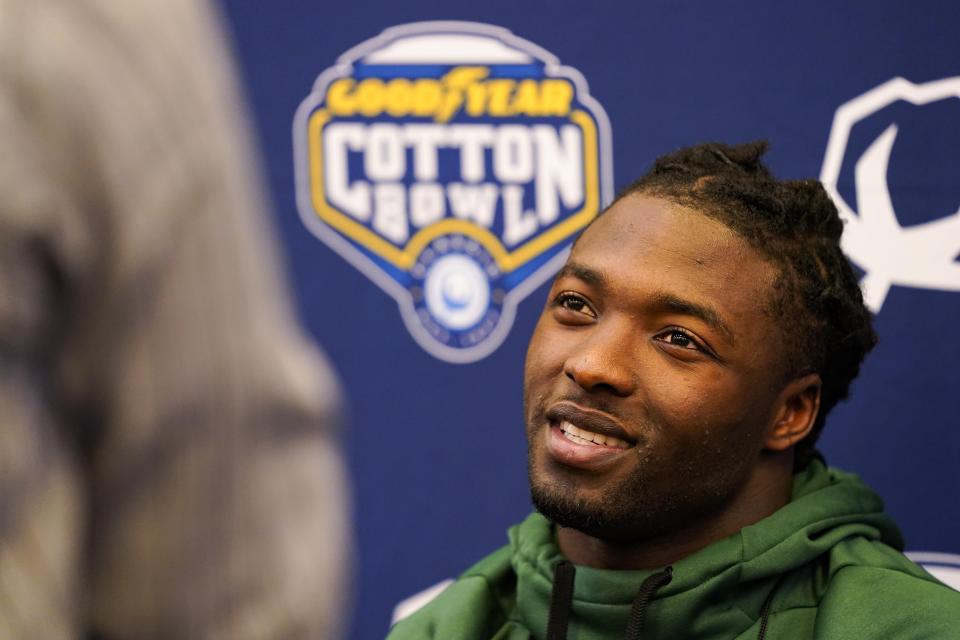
[{"left": 216, "top": 0, "right": 960, "bottom": 638}]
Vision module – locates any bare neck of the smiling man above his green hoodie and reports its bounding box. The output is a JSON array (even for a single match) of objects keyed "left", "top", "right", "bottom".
[{"left": 557, "top": 456, "right": 793, "bottom": 570}]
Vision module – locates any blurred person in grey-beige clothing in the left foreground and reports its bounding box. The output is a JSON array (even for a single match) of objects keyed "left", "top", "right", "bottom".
[{"left": 0, "top": 0, "right": 350, "bottom": 640}]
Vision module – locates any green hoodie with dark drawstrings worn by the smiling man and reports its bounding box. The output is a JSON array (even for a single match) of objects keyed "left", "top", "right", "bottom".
[{"left": 389, "top": 462, "right": 960, "bottom": 640}]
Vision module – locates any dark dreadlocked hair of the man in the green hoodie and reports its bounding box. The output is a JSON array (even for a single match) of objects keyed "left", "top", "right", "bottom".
[{"left": 617, "top": 141, "right": 877, "bottom": 470}]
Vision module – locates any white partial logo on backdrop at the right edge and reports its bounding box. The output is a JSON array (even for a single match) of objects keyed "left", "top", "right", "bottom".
[{"left": 820, "top": 77, "right": 960, "bottom": 313}]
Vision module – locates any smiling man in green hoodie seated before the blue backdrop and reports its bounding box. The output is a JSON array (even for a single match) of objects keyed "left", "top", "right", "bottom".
[{"left": 391, "top": 144, "right": 960, "bottom": 640}]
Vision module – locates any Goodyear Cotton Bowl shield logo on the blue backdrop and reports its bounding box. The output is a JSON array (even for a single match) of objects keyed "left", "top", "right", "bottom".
[{"left": 294, "top": 22, "right": 611, "bottom": 362}]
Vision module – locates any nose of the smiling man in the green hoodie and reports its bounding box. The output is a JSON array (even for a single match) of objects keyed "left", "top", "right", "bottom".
[{"left": 563, "top": 330, "right": 636, "bottom": 397}]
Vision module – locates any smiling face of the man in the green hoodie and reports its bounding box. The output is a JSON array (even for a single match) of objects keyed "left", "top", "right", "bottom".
[{"left": 524, "top": 195, "right": 784, "bottom": 542}]
